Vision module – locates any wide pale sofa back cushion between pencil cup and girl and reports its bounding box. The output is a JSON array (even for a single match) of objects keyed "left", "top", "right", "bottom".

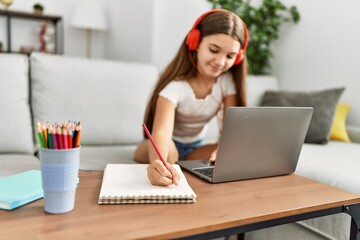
[{"left": 30, "top": 53, "right": 158, "bottom": 145}]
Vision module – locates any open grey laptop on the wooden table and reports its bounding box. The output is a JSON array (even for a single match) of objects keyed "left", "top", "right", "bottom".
[{"left": 178, "top": 107, "right": 313, "bottom": 183}]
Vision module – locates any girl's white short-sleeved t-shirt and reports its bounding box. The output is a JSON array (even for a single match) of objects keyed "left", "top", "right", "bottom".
[{"left": 159, "top": 72, "right": 236, "bottom": 143}]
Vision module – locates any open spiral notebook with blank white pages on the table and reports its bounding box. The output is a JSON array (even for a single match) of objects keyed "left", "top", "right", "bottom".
[{"left": 98, "top": 164, "right": 196, "bottom": 204}]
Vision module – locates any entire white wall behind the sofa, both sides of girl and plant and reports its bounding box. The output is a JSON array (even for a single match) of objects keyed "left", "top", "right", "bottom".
[{"left": 0, "top": 0, "right": 360, "bottom": 126}]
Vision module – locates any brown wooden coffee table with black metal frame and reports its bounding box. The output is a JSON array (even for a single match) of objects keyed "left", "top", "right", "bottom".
[{"left": 0, "top": 172, "right": 360, "bottom": 240}]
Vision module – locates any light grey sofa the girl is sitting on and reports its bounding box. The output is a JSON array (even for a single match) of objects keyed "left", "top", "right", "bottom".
[{"left": 0, "top": 53, "right": 360, "bottom": 239}]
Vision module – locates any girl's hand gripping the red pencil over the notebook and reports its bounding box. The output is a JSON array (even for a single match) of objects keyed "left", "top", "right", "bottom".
[{"left": 147, "top": 159, "right": 180, "bottom": 186}]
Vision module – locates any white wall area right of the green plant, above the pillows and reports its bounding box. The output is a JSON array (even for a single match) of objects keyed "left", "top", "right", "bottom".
[{"left": 273, "top": 0, "right": 360, "bottom": 126}]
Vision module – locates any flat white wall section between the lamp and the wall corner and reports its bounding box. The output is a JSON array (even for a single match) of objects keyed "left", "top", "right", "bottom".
[{"left": 104, "top": 0, "right": 154, "bottom": 62}]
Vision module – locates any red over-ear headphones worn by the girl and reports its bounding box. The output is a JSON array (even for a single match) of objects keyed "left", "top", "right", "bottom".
[{"left": 185, "top": 9, "right": 249, "bottom": 65}]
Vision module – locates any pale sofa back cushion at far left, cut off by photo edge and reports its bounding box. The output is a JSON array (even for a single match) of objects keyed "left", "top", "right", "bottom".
[{"left": 0, "top": 54, "right": 34, "bottom": 153}]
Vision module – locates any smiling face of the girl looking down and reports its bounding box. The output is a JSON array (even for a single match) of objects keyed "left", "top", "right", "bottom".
[{"left": 197, "top": 33, "right": 240, "bottom": 78}]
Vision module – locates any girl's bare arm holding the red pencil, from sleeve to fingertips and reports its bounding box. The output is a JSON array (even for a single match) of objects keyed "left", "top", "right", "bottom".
[{"left": 148, "top": 97, "right": 179, "bottom": 186}]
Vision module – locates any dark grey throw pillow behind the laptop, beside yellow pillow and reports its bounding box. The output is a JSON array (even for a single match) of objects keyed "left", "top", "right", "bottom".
[{"left": 261, "top": 88, "right": 345, "bottom": 143}]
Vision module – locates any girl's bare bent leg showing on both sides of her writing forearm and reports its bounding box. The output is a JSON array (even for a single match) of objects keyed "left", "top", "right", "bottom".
[{"left": 134, "top": 139, "right": 179, "bottom": 163}]
